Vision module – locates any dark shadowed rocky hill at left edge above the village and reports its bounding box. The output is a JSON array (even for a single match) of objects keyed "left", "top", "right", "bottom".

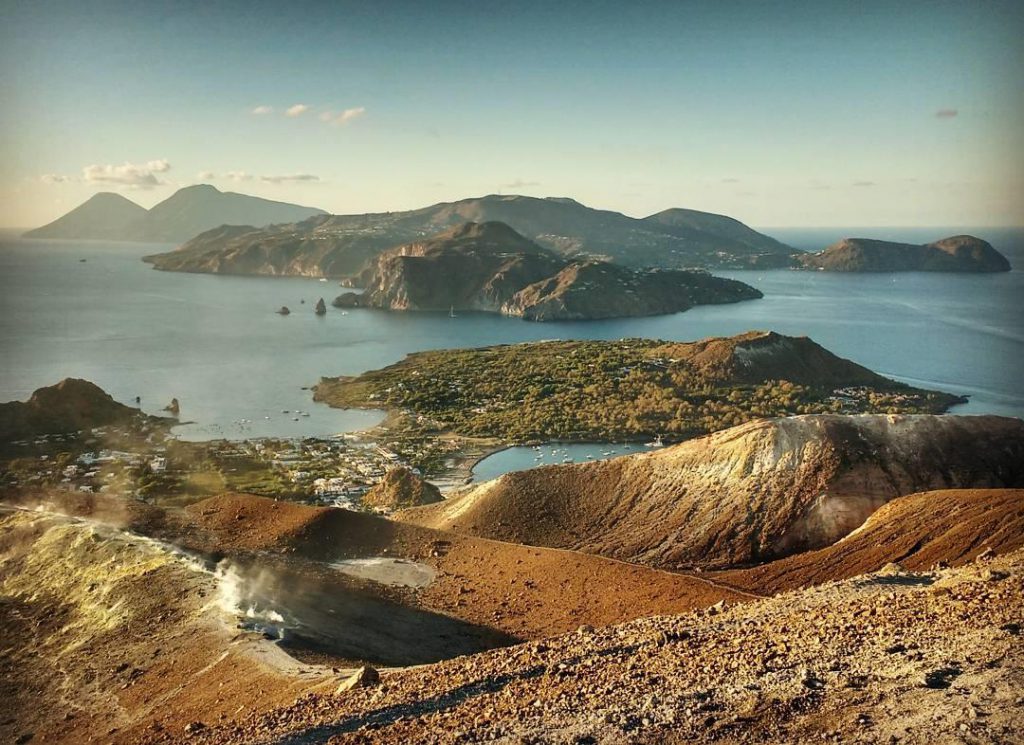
[{"left": 0, "top": 378, "right": 151, "bottom": 441}]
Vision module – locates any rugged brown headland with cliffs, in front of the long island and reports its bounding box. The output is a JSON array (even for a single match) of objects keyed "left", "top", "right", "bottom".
[{"left": 327, "top": 222, "right": 761, "bottom": 320}]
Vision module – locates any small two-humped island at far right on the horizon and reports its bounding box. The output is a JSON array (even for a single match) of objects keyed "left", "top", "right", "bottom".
[{"left": 798, "top": 235, "right": 1010, "bottom": 272}]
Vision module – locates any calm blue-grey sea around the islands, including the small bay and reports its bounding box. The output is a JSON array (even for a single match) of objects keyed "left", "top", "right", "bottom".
[{"left": 0, "top": 227, "right": 1024, "bottom": 477}]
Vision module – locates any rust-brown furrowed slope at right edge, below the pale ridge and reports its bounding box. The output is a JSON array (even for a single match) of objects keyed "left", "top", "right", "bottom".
[{"left": 716, "top": 489, "right": 1024, "bottom": 593}]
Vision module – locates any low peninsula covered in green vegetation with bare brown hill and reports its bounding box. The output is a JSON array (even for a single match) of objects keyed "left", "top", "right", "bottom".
[{"left": 315, "top": 334, "right": 959, "bottom": 442}]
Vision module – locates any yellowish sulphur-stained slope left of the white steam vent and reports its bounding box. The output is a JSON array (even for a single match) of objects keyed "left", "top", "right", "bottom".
[{"left": 0, "top": 512, "right": 333, "bottom": 743}]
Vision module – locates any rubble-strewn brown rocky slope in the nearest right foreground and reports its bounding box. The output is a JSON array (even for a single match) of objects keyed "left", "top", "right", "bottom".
[{"left": 176, "top": 552, "right": 1024, "bottom": 745}]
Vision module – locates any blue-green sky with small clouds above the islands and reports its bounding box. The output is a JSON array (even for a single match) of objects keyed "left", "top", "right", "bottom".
[{"left": 0, "top": 0, "right": 1024, "bottom": 227}]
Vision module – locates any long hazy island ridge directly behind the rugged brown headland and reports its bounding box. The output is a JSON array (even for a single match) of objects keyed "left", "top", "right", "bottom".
[{"left": 142, "top": 194, "right": 799, "bottom": 277}]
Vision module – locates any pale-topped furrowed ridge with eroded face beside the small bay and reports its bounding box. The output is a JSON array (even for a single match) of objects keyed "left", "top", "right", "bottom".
[{"left": 398, "top": 414, "right": 1024, "bottom": 568}]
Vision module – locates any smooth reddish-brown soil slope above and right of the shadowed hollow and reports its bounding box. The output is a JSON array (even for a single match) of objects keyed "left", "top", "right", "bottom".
[{"left": 188, "top": 494, "right": 744, "bottom": 639}]
